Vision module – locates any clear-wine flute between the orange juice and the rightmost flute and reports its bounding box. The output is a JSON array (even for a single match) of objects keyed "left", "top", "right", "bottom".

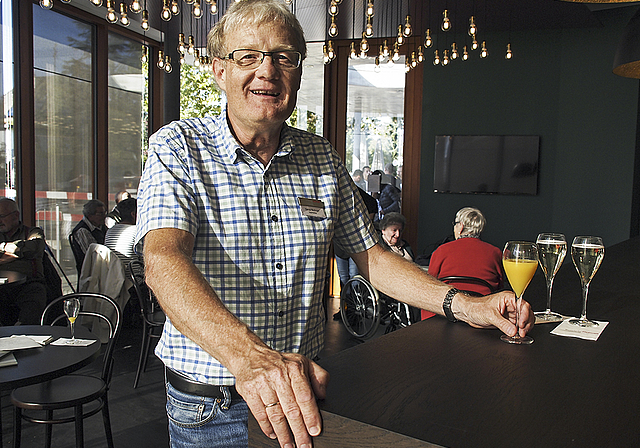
[{"left": 535, "top": 233, "right": 567, "bottom": 322}]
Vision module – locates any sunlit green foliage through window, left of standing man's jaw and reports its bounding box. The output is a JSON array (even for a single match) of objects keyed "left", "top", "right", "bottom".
[{"left": 180, "top": 64, "right": 222, "bottom": 118}]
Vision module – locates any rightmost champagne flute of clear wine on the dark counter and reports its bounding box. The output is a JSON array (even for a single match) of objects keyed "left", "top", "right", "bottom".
[{"left": 569, "top": 236, "right": 604, "bottom": 327}]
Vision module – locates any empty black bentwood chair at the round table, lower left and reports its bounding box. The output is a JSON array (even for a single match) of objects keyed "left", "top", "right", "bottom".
[{"left": 11, "top": 292, "right": 122, "bottom": 448}]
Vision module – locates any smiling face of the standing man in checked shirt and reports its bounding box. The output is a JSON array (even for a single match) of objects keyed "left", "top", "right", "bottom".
[{"left": 213, "top": 23, "right": 302, "bottom": 135}]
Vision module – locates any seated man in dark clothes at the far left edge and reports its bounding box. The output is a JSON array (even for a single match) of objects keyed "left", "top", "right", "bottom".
[{"left": 0, "top": 197, "right": 47, "bottom": 325}]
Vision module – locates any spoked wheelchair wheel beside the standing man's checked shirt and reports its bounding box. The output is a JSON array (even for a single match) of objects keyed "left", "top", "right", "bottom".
[{"left": 340, "top": 275, "right": 380, "bottom": 339}]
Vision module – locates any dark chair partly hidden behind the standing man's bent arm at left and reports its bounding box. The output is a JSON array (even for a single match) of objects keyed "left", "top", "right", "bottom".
[{"left": 127, "top": 260, "right": 165, "bottom": 389}]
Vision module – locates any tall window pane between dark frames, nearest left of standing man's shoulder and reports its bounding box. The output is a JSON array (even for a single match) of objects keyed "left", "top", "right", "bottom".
[{"left": 107, "top": 33, "right": 148, "bottom": 208}]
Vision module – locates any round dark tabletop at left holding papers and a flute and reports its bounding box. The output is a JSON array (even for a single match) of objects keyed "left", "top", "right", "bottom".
[{"left": 0, "top": 324, "right": 101, "bottom": 445}]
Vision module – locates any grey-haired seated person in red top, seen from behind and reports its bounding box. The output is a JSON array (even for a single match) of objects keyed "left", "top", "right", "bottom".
[{"left": 429, "top": 207, "right": 504, "bottom": 295}]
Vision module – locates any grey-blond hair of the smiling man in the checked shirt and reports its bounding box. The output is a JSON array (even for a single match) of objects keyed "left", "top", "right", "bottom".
[{"left": 207, "top": 0, "right": 307, "bottom": 59}]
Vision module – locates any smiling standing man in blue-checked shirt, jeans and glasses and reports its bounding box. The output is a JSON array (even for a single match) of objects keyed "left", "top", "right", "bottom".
[{"left": 136, "top": 0, "right": 532, "bottom": 448}]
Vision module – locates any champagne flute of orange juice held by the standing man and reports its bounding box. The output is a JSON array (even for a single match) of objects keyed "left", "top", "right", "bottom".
[{"left": 500, "top": 241, "right": 538, "bottom": 344}]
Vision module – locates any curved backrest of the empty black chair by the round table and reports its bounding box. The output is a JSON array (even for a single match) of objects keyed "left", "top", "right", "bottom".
[{"left": 40, "top": 292, "right": 122, "bottom": 385}]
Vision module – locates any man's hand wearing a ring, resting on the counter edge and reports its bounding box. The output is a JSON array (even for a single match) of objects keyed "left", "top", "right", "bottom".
[{"left": 234, "top": 350, "right": 329, "bottom": 448}]
